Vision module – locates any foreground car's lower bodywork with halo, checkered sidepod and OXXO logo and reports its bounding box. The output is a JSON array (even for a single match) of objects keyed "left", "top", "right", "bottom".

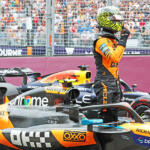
[{"left": 0, "top": 103, "right": 150, "bottom": 150}]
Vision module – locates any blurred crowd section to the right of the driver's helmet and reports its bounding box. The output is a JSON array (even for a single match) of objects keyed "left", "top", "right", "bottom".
[{"left": 118, "top": 0, "right": 150, "bottom": 47}]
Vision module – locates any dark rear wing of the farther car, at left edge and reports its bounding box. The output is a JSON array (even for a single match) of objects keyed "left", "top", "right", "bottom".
[{"left": 0, "top": 68, "right": 41, "bottom": 84}]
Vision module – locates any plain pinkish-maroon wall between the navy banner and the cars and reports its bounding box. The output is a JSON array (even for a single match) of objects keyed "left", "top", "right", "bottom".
[{"left": 0, "top": 55, "right": 150, "bottom": 92}]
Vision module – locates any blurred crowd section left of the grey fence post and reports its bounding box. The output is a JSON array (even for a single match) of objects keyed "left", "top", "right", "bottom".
[{"left": 0, "top": 0, "right": 46, "bottom": 44}]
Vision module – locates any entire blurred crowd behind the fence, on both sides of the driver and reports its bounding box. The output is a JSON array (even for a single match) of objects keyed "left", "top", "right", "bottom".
[{"left": 0, "top": 0, "right": 150, "bottom": 45}]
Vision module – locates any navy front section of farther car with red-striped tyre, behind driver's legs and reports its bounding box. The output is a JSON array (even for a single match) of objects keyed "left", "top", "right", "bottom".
[{"left": 72, "top": 80, "right": 150, "bottom": 115}]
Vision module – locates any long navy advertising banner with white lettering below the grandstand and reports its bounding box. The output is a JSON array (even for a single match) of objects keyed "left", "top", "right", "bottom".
[{"left": 0, "top": 46, "right": 150, "bottom": 57}]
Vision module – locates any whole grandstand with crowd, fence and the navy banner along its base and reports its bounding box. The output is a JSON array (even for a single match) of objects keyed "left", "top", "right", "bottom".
[{"left": 0, "top": 0, "right": 150, "bottom": 56}]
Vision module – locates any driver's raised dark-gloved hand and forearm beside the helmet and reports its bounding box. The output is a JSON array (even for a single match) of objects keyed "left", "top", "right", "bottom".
[{"left": 118, "top": 28, "right": 130, "bottom": 47}]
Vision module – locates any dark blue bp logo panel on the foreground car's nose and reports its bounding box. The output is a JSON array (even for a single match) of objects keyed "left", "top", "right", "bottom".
[{"left": 131, "top": 133, "right": 150, "bottom": 147}]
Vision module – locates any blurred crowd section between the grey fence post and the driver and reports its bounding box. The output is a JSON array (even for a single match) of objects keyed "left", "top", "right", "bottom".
[{"left": 55, "top": 0, "right": 106, "bottom": 46}]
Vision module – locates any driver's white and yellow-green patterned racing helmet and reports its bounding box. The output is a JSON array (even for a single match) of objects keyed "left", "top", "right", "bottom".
[{"left": 97, "top": 6, "right": 123, "bottom": 33}]
